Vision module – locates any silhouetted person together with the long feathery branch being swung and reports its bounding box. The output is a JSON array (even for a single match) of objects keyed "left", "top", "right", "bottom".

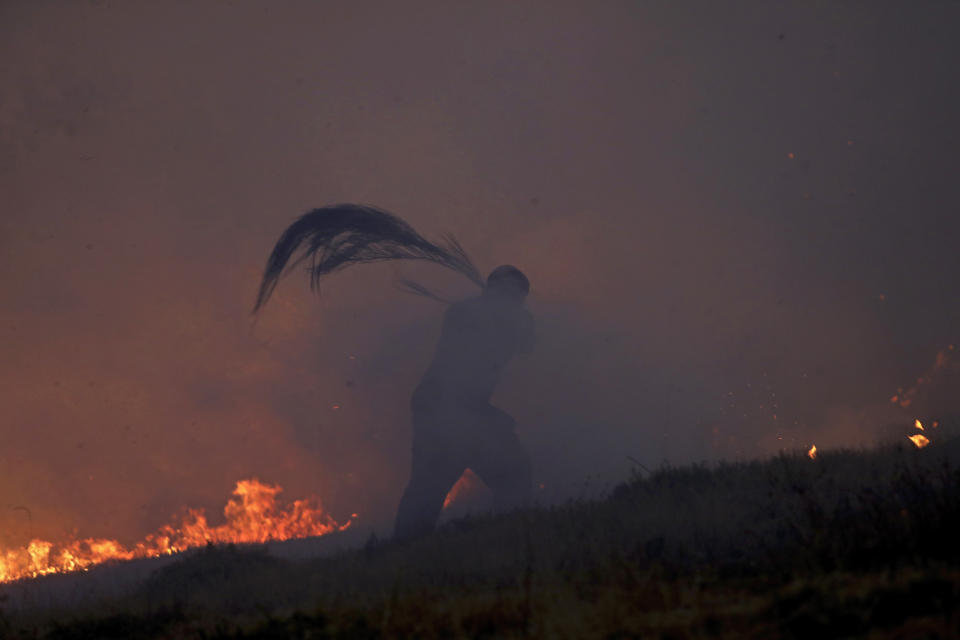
[{"left": 253, "top": 203, "right": 533, "bottom": 537}]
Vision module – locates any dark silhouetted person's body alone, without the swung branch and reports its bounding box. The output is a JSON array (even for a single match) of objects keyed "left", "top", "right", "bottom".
[{"left": 394, "top": 265, "right": 534, "bottom": 538}]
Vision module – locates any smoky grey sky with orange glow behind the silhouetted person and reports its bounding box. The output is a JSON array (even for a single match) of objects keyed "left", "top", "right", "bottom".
[{"left": 0, "top": 1, "right": 960, "bottom": 545}]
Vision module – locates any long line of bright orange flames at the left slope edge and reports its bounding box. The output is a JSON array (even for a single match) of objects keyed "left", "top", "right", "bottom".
[{"left": 0, "top": 478, "right": 356, "bottom": 582}]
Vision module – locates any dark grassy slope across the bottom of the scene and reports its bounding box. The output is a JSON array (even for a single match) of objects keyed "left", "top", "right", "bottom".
[{"left": 0, "top": 440, "right": 960, "bottom": 638}]
